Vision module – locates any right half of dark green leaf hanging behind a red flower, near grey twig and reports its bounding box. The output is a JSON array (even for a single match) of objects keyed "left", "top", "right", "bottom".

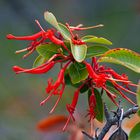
[{"left": 94, "top": 89, "right": 104, "bottom": 122}]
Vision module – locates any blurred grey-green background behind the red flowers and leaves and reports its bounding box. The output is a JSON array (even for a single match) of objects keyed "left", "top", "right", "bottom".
[{"left": 0, "top": 0, "right": 140, "bottom": 140}]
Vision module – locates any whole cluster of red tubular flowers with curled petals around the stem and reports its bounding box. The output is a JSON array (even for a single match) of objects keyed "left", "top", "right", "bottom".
[{"left": 7, "top": 12, "right": 137, "bottom": 130}]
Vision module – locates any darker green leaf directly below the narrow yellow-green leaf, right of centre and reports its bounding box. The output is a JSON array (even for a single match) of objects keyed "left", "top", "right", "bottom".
[{"left": 86, "top": 46, "right": 109, "bottom": 58}]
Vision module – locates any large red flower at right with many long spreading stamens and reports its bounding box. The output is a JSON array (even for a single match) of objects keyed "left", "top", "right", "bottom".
[{"left": 84, "top": 61, "right": 136, "bottom": 105}]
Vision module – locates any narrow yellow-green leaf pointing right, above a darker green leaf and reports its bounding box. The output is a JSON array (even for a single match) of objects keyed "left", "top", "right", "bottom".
[{"left": 82, "top": 35, "right": 112, "bottom": 45}]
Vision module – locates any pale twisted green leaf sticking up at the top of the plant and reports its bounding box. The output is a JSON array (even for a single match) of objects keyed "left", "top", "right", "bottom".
[{"left": 44, "top": 11, "right": 71, "bottom": 40}]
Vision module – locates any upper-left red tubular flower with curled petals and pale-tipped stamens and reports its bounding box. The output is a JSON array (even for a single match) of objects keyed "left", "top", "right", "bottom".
[{"left": 7, "top": 20, "right": 66, "bottom": 58}]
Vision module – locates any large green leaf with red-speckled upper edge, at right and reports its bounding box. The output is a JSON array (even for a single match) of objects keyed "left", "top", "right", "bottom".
[{"left": 98, "top": 48, "right": 140, "bottom": 73}]
